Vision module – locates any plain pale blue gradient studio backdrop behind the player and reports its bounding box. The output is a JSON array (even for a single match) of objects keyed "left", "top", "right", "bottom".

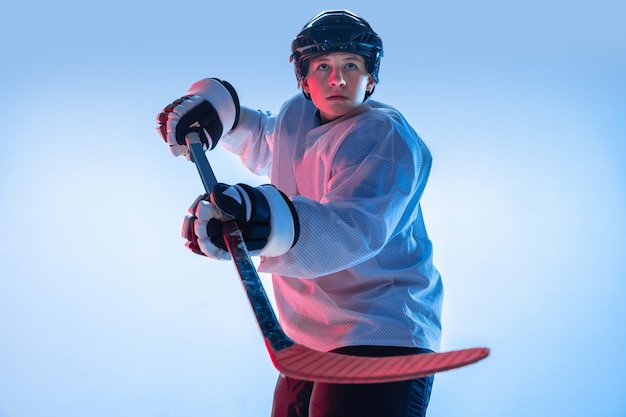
[{"left": 0, "top": 0, "right": 626, "bottom": 417}]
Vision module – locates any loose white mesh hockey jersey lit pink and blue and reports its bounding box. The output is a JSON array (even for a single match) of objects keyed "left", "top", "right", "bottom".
[{"left": 220, "top": 94, "right": 443, "bottom": 351}]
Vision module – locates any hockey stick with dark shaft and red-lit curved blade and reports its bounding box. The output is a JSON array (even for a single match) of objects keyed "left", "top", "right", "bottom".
[{"left": 187, "top": 133, "right": 489, "bottom": 384}]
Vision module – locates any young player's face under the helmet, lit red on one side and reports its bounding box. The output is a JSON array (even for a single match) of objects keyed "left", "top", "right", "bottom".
[{"left": 302, "top": 52, "right": 376, "bottom": 122}]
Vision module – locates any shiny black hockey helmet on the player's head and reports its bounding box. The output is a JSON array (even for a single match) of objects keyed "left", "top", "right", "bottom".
[{"left": 290, "top": 10, "right": 383, "bottom": 98}]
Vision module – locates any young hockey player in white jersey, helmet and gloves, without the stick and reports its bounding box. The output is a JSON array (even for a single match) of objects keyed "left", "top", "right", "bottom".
[{"left": 158, "top": 10, "right": 443, "bottom": 417}]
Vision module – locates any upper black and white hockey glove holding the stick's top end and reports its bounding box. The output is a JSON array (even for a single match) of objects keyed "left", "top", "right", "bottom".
[{"left": 157, "top": 78, "right": 239, "bottom": 156}]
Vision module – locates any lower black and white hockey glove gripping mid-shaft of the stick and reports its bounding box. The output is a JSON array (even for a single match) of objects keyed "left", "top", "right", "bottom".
[{"left": 182, "top": 183, "right": 300, "bottom": 259}]
